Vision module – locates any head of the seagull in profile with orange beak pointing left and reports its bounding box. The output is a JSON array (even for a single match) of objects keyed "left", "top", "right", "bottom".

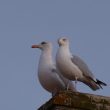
[{"left": 31, "top": 41, "right": 52, "bottom": 50}]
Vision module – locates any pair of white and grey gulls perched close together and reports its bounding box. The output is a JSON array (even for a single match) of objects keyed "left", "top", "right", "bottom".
[{"left": 32, "top": 37, "right": 107, "bottom": 95}]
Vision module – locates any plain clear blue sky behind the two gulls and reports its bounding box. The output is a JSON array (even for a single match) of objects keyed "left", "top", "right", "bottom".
[{"left": 0, "top": 0, "right": 110, "bottom": 110}]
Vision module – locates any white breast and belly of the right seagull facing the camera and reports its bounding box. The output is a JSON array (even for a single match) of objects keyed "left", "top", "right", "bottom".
[{"left": 56, "top": 48, "right": 82, "bottom": 80}]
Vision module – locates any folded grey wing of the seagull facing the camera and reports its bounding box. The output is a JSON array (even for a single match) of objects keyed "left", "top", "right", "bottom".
[{"left": 71, "top": 55, "right": 94, "bottom": 79}]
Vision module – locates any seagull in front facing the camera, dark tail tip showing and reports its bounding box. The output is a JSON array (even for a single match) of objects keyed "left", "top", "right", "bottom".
[{"left": 56, "top": 37, "right": 107, "bottom": 91}]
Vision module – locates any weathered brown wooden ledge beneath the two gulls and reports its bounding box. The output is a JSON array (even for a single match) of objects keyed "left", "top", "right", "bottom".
[{"left": 38, "top": 91, "right": 110, "bottom": 110}]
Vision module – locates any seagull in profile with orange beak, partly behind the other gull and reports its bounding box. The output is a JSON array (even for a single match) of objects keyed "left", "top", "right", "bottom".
[{"left": 32, "top": 41, "right": 76, "bottom": 96}]
